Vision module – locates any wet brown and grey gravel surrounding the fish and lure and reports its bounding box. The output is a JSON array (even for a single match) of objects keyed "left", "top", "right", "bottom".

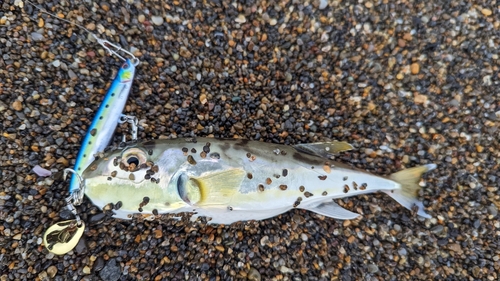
[{"left": 0, "top": 0, "right": 500, "bottom": 280}]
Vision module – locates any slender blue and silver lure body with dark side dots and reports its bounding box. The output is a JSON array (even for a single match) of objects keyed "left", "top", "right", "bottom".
[{"left": 69, "top": 59, "right": 135, "bottom": 193}]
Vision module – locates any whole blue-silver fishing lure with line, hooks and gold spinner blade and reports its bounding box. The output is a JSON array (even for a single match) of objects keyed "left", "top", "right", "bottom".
[{"left": 27, "top": 1, "right": 139, "bottom": 254}]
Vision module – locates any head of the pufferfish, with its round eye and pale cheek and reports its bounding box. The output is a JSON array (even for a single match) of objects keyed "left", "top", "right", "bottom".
[{"left": 82, "top": 144, "right": 187, "bottom": 213}]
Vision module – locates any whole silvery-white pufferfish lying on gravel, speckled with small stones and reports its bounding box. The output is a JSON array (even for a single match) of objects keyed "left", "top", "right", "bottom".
[{"left": 82, "top": 138, "right": 436, "bottom": 224}]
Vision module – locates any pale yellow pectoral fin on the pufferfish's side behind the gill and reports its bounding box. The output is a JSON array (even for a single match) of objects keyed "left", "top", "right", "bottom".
[{"left": 189, "top": 169, "right": 246, "bottom": 206}]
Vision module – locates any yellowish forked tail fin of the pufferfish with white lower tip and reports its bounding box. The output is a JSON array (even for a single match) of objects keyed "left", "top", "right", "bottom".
[{"left": 385, "top": 164, "right": 436, "bottom": 218}]
